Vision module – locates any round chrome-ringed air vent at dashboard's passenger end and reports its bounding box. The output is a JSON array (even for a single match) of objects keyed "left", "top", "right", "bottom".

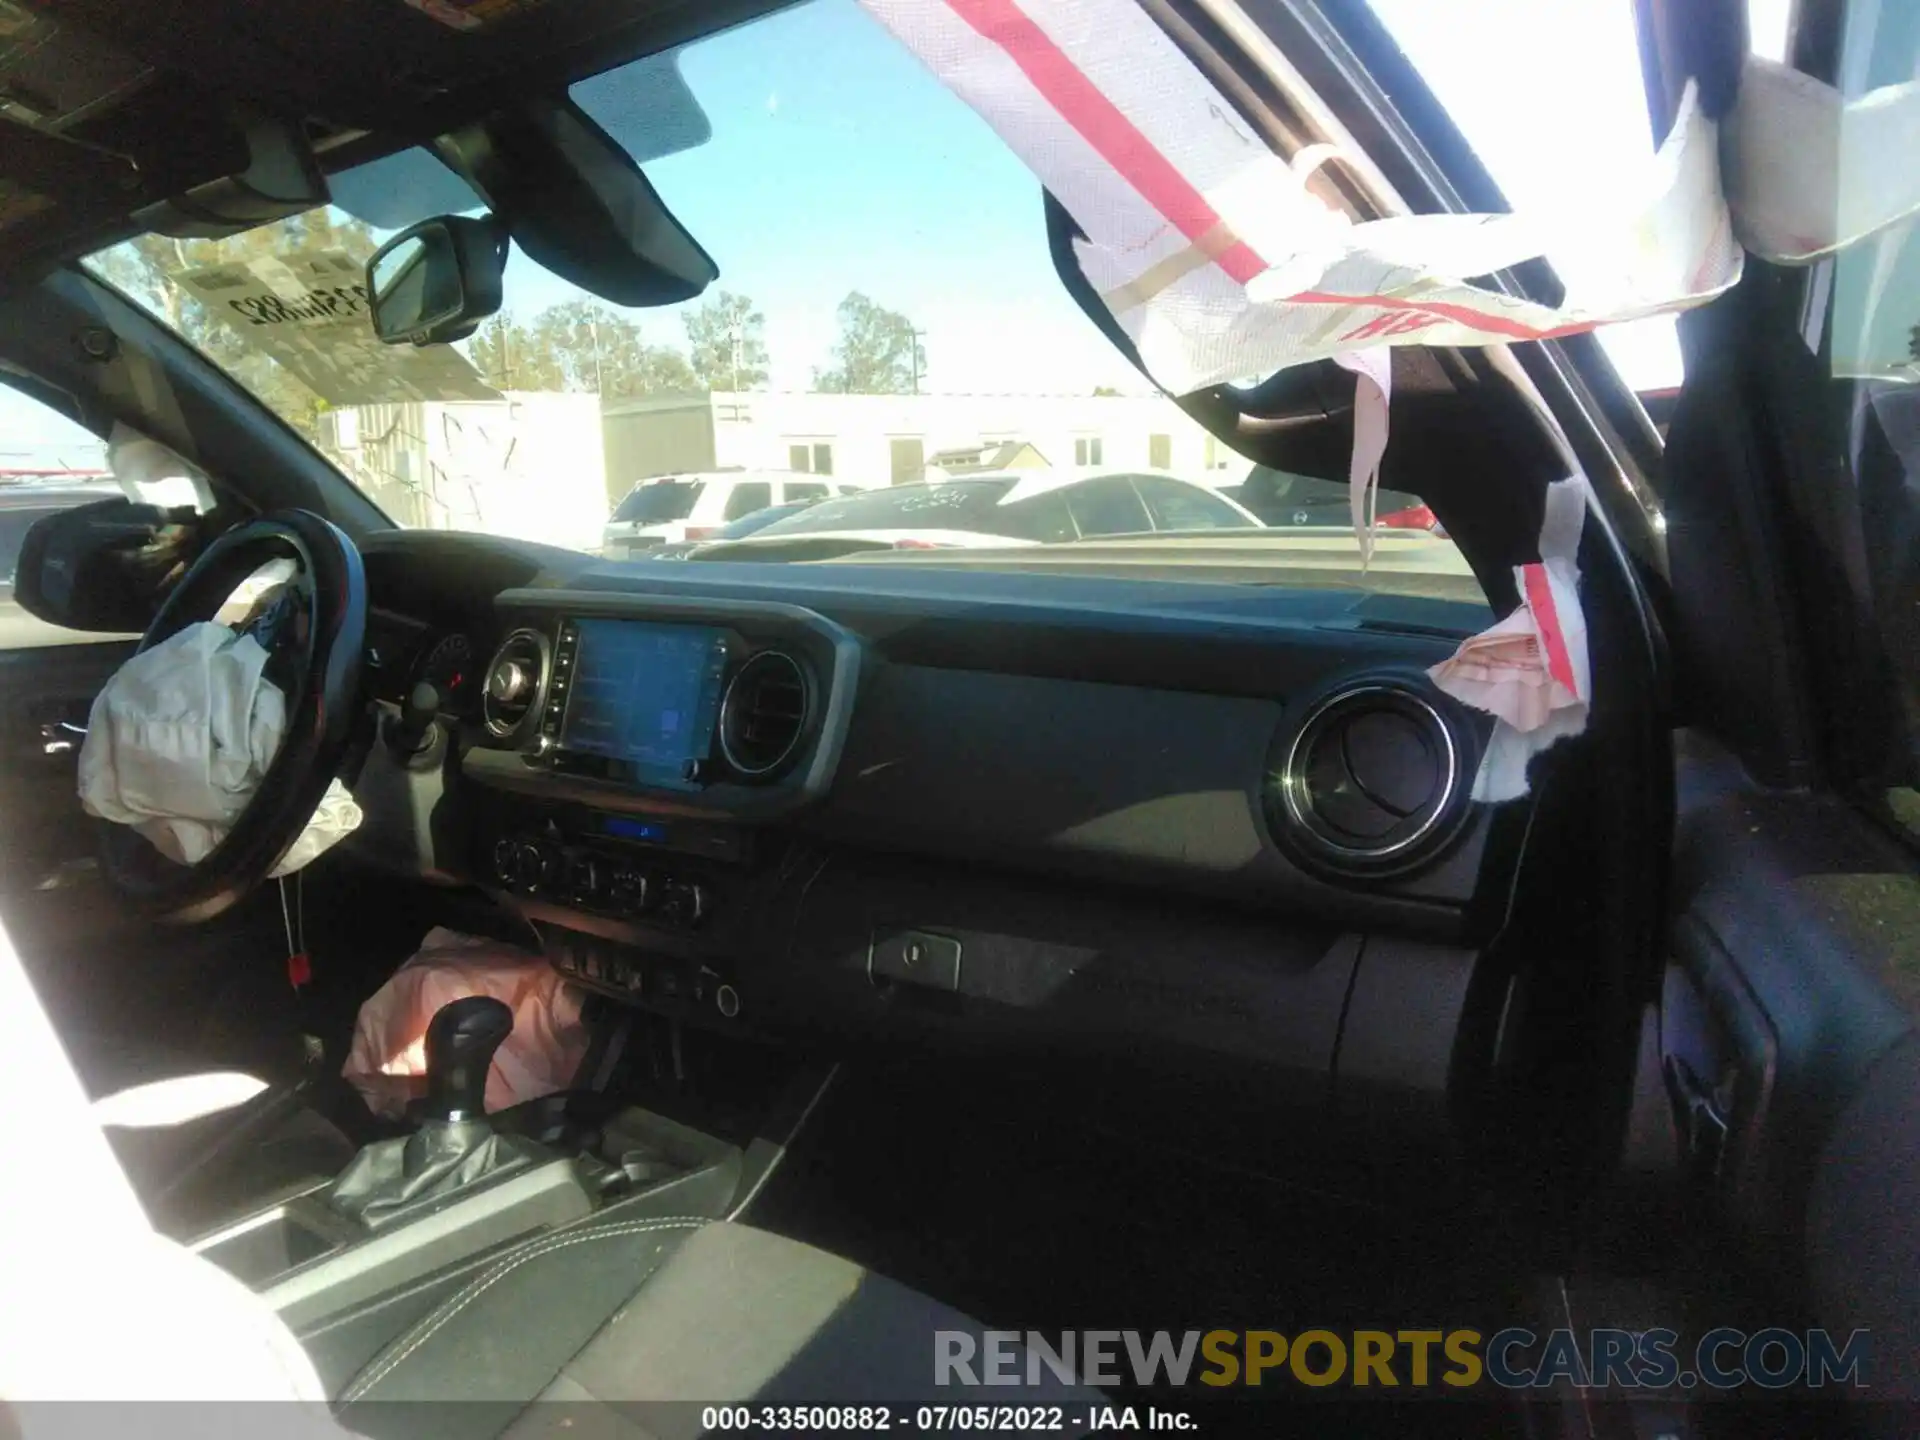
[{"left": 1265, "top": 680, "right": 1469, "bottom": 877}]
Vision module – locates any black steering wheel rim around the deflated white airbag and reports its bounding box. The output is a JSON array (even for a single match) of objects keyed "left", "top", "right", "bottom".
[{"left": 100, "top": 511, "right": 367, "bottom": 924}]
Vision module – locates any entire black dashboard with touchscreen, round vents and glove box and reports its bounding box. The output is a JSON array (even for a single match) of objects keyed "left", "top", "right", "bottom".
[{"left": 355, "top": 536, "right": 1526, "bottom": 1167}]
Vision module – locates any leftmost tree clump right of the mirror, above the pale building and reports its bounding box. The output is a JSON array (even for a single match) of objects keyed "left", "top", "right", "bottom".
[{"left": 467, "top": 300, "right": 699, "bottom": 399}]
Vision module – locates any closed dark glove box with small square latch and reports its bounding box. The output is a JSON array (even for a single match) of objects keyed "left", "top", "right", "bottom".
[{"left": 764, "top": 852, "right": 1484, "bottom": 1142}]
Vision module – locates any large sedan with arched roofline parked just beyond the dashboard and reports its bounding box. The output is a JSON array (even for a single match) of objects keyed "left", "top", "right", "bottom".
[{"left": 693, "top": 470, "right": 1261, "bottom": 559}]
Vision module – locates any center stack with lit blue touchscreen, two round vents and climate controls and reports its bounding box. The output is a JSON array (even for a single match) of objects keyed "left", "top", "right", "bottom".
[{"left": 461, "top": 589, "right": 864, "bottom": 1027}]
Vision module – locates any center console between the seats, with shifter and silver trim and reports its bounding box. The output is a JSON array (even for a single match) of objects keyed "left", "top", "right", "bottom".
[{"left": 188, "top": 996, "right": 824, "bottom": 1390}]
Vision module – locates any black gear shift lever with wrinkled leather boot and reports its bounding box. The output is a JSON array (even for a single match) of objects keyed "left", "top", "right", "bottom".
[{"left": 326, "top": 995, "right": 540, "bottom": 1227}]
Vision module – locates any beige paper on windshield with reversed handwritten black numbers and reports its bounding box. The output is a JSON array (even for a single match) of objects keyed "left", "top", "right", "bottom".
[{"left": 175, "top": 250, "right": 499, "bottom": 405}]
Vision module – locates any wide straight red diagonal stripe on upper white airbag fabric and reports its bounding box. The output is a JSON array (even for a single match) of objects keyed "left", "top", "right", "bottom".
[{"left": 947, "top": 0, "right": 1267, "bottom": 284}]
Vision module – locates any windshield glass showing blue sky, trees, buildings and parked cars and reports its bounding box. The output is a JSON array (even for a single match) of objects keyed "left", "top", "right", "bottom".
[{"left": 88, "top": 0, "right": 1480, "bottom": 601}]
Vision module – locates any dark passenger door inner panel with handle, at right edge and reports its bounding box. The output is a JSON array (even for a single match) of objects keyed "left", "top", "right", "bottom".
[{"left": 1663, "top": 735, "right": 1920, "bottom": 1260}]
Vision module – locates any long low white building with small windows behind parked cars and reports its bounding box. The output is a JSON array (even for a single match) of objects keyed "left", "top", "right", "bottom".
[{"left": 603, "top": 392, "right": 1250, "bottom": 499}]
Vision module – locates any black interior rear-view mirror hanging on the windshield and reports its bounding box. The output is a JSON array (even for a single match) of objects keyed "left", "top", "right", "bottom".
[{"left": 367, "top": 215, "right": 507, "bottom": 346}]
